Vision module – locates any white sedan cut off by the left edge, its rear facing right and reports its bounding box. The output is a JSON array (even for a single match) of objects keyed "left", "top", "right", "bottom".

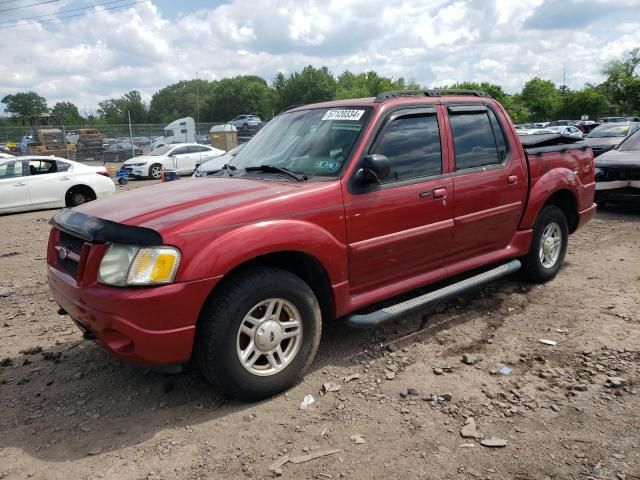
[{"left": 0, "top": 156, "right": 116, "bottom": 213}]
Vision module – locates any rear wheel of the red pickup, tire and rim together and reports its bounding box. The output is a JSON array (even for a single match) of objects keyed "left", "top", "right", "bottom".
[{"left": 522, "top": 205, "right": 569, "bottom": 283}]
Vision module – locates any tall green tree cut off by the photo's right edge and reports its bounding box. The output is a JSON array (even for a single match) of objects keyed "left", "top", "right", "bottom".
[{"left": 602, "top": 48, "right": 640, "bottom": 114}]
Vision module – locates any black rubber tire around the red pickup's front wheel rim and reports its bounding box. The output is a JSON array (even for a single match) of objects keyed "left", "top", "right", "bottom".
[{"left": 195, "top": 267, "right": 322, "bottom": 401}]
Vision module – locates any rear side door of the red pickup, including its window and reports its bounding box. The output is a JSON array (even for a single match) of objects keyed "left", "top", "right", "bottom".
[{"left": 447, "top": 105, "right": 528, "bottom": 263}]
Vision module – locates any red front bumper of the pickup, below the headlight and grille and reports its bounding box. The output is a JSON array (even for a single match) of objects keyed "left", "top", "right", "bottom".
[{"left": 48, "top": 265, "right": 219, "bottom": 366}]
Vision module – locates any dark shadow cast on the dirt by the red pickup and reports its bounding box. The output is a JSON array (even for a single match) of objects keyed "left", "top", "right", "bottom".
[{"left": 0, "top": 279, "right": 526, "bottom": 461}]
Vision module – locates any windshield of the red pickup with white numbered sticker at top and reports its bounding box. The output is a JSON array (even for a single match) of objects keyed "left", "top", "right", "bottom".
[{"left": 230, "top": 107, "right": 372, "bottom": 177}]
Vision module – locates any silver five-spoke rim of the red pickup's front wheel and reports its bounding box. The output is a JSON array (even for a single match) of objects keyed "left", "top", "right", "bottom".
[{"left": 236, "top": 298, "right": 302, "bottom": 377}]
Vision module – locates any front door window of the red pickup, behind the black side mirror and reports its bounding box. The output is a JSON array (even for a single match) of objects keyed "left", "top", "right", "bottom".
[{"left": 372, "top": 113, "right": 442, "bottom": 183}]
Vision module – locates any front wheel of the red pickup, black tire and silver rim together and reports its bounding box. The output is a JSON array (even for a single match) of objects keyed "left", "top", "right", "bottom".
[{"left": 196, "top": 267, "right": 321, "bottom": 400}]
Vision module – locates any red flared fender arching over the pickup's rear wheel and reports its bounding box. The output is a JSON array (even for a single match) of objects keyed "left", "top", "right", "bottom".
[{"left": 519, "top": 168, "right": 580, "bottom": 229}]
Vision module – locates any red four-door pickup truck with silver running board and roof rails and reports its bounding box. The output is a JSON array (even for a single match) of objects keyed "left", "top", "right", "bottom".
[{"left": 48, "top": 90, "right": 595, "bottom": 399}]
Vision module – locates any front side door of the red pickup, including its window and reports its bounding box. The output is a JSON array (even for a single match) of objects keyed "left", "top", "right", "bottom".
[{"left": 344, "top": 108, "right": 453, "bottom": 294}]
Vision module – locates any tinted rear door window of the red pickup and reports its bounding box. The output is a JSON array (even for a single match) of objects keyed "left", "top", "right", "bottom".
[{"left": 449, "top": 109, "right": 507, "bottom": 170}]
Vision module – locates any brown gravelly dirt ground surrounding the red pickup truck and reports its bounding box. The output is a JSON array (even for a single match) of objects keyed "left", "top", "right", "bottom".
[{"left": 0, "top": 182, "right": 640, "bottom": 480}]
